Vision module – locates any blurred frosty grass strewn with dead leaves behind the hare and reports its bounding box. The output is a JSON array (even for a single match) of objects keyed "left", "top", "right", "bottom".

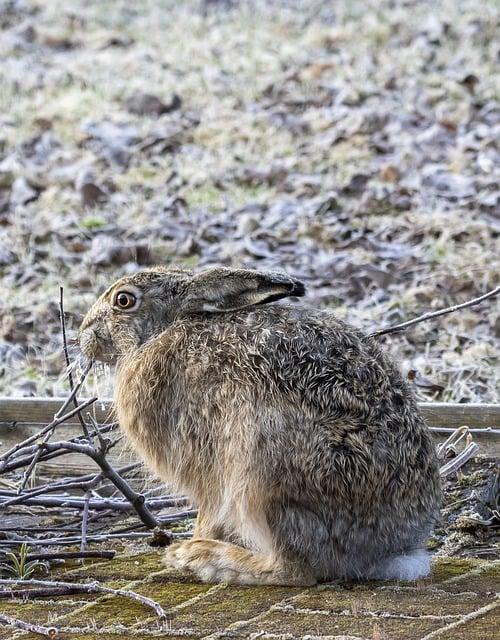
[{"left": 0, "top": 0, "right": 500, "bottom": 402}]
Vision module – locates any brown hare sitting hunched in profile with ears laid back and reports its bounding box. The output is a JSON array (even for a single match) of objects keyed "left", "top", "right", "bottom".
[{"left": 79, "top": 267, "right": 440, "bottom": 585}]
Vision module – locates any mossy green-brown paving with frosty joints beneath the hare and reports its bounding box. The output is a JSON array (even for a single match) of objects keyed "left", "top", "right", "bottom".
[{"left": 0, "top": 551, "right": 500, "bottom": 640}]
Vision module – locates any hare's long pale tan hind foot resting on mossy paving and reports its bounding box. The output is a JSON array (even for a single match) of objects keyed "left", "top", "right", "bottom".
[{"left": 163, "top": 538, "right": 316, "bottom": 586}]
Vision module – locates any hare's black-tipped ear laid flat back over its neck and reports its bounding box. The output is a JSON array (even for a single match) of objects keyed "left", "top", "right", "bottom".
[{"left": 183, "top": 268, "right": 305, "bottom": 312}]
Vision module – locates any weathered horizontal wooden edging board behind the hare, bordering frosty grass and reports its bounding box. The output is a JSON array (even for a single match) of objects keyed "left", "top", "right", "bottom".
[{"left": 0, "top": 397, "right": 500, "bottom": 428}]
